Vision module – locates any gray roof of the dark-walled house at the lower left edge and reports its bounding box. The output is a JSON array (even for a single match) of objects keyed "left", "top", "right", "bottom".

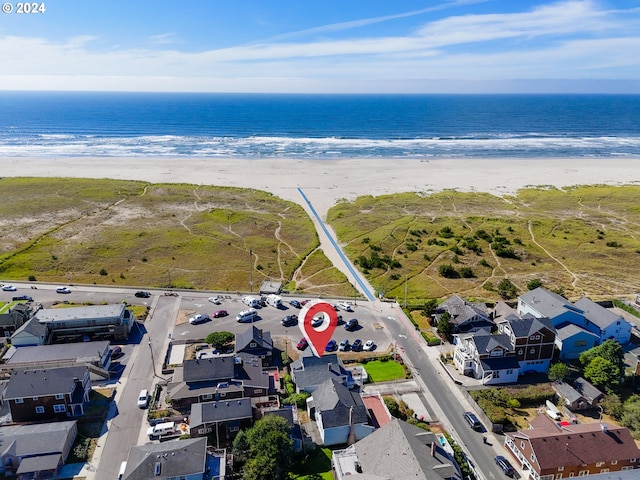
[{"left": 4, "top": 366, "right": 88, "bottom": 400}]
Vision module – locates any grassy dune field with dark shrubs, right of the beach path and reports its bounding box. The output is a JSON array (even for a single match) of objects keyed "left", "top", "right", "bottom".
[{"left": 327, "top": 186, "right": 640, "bottom": 305}]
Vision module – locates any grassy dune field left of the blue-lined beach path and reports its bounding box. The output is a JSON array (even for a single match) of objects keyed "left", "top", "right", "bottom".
[{"left": 0, "top": 178, "right": 360, "bottom": 296}]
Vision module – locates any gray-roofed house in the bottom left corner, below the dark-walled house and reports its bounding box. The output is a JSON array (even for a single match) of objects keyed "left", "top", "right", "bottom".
[{"left": 0, "top": 420, "right": 78, "bottom": 478}]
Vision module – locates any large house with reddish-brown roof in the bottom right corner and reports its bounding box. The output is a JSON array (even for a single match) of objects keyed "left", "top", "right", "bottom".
[{"left": 504, "top": 415, "right": 640, "bottom": 480}]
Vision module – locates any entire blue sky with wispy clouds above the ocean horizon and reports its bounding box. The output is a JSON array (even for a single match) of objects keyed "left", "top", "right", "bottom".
[{"left": 0, "top": 0, "right": 640, "bottom": 93}]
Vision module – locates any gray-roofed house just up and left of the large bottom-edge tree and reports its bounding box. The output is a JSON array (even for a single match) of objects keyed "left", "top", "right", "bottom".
[{"left": 189, "top": 398, "right": 253, "bottom": 448}]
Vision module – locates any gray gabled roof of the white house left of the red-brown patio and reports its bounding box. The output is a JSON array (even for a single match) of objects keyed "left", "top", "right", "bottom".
[{"left": 313, "top": 378, "right": 369, "bottom": 428}]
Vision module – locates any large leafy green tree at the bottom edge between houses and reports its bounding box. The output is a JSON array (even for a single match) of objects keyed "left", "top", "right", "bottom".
[{"left": 242, "top": 415, "right": 293, "bottom": 480}]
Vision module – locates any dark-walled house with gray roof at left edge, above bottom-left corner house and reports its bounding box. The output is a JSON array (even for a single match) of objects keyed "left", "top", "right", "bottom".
[{"left": 3, "top": 366, "right": 91, "bottom": 422}]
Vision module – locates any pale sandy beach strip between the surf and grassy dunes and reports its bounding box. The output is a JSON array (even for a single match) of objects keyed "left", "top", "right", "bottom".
[{"left": 1, "top": 157, "right": 640, "bottom": 217}]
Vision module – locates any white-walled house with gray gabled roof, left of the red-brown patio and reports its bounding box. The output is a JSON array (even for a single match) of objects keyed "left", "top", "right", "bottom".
[{"left": 307, "top": 378, "right": 375, "bottom": 446}]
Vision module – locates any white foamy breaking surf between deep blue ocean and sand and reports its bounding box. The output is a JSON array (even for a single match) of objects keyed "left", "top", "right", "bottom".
[{"left": 0, "top": 133, "right": 640, "bottom": 159}]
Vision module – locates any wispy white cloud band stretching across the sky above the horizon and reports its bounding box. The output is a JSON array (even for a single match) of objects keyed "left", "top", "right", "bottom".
[{"left": 0, "top": 1, "right": 640, "bottom": 91}]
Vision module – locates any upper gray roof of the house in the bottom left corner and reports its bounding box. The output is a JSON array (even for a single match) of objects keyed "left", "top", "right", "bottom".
[{"left": 0, "top": 420, "right": 76, "bottom": 457}]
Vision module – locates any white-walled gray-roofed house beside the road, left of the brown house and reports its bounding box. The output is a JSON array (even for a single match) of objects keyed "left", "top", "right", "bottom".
[{"left": 453, "top": 331, "right": 520, "bottom": 385}]
